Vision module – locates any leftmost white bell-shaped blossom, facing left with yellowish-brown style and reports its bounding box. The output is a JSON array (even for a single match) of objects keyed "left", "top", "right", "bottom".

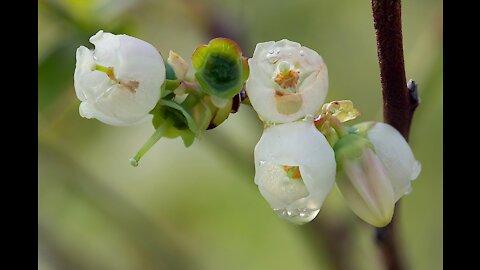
[{"left": 74, "top": 31, "right": 165, "bottom": 126}]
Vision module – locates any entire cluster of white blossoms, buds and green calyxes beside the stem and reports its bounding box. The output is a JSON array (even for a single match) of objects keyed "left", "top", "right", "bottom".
[{"left": 74, "top": 31, "right": 420, "bottom": 227}]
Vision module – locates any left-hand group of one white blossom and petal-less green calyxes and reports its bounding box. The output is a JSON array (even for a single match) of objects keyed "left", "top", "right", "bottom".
[{"left": 74, "top": 31, "right": 249, "bottom": 166}]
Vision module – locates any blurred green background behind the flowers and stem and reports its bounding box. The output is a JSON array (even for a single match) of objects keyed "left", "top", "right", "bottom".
[{"left": 38, "top": 0, "right": 443, "bottom": 270}]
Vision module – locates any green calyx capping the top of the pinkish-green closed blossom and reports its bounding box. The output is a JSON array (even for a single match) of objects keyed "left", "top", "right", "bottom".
[{"left": 333, "top": 133, "right": 375, "bottom": 170}]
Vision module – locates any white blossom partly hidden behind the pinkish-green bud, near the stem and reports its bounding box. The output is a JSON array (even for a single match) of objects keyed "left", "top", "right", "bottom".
[{"left": 368, "top": 122, "right": 421, "bottom": 201}]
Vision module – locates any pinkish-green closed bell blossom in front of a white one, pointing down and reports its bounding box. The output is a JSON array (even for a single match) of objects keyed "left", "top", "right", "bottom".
[{"left": 333, "top": 134, "right": 395, "bottom": 227}]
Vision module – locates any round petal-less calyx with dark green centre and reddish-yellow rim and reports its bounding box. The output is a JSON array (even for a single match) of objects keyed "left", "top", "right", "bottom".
[{"left": 192, "top": 38, "right": 249, "bottom": 98}]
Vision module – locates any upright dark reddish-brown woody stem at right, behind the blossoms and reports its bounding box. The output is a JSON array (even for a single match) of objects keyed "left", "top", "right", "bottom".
[{"left": 372, "top": 0, "right": 418, "bottom": 270}]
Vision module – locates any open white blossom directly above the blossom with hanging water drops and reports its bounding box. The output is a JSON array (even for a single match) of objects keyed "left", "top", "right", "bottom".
[{"left": 246, "top": 39, "right": 328, "bottom": 123}]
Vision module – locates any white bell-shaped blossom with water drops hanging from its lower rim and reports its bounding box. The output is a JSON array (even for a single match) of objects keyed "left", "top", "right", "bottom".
[{"left": 255, "top": 121, "right": 335, "bottom": 224}]
